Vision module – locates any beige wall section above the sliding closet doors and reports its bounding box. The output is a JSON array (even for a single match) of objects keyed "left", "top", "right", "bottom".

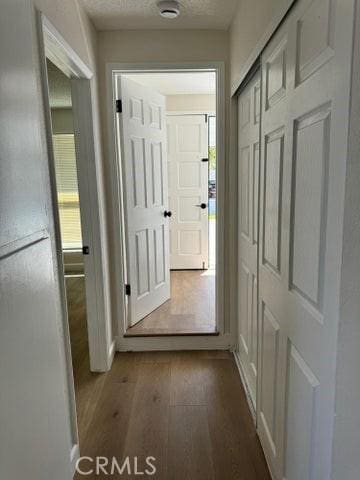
[{"left": 230, "top": 0, "right": 293, "bottom": 90}]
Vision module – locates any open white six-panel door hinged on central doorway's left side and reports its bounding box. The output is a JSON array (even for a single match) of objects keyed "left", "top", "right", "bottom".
[{"left": 118, "top": 76, "right": 170, "bottom": 325}]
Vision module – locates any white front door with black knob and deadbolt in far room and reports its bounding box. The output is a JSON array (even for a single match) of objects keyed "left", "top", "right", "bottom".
[{"left": 167, "top": 115, "right": 209, "bottom": 270}]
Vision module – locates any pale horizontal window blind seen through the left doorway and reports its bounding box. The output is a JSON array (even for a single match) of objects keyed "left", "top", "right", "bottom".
[{"left": 53, "top": 134, "right": 82, "bottom": 249}]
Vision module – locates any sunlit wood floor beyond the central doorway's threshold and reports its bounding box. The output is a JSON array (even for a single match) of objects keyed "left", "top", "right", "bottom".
[{"left": 126, "top": 270, "right": 217, "bottom": 337}]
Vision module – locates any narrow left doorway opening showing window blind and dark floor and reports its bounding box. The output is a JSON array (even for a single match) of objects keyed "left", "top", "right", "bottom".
[{"left": 46, "top": 58, "right": 90, "bottom": 439}]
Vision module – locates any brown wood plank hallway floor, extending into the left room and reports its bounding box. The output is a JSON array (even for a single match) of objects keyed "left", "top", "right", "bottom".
[{"left": 67, "top": 279, "right": 270, "bottom": 480}]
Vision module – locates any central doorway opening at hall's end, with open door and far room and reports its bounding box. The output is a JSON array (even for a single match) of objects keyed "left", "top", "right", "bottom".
[{"left": 114, "top": 71, "right": 218, "bottom": 337}]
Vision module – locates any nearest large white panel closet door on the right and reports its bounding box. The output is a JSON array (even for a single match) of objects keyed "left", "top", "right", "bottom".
[{"left": 257, "top": 0, "right": 353, "bottom": 480}]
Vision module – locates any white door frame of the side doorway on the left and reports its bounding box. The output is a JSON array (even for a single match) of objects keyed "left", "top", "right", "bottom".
[{"left": 37, "top": 12, "right": 111, "bottom": 378}]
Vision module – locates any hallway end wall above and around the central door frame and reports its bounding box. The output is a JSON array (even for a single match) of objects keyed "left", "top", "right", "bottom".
[{"left": 98, "top": 30, "right": 229, "bottom": 336}]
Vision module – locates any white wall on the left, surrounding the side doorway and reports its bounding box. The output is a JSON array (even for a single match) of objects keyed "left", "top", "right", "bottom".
[{"left": 0, "top": 0, "right": 106, "bottom": 480}]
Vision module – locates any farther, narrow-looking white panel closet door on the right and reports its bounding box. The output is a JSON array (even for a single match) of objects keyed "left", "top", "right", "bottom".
[{"left": 238, "top": 71, "right": 261, "bottom": 407}]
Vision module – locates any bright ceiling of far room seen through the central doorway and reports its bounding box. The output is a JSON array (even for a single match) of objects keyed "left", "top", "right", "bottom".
[{"left": 126, "top": 72, "right": 216, "bottom": 95}]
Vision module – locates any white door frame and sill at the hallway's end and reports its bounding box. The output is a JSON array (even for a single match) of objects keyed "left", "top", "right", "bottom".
[{"left": 106, "top": 62, "right": 228, "bottom": 351}]
